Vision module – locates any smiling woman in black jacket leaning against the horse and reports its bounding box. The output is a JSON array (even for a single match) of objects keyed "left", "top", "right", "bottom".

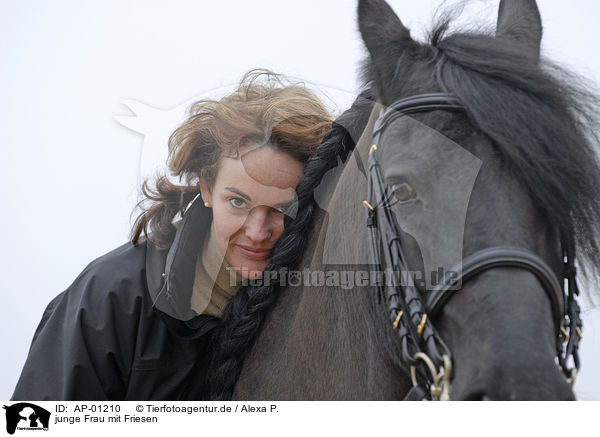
[{"left": 13, "top": 72, "right": 331, "bottom": 400}]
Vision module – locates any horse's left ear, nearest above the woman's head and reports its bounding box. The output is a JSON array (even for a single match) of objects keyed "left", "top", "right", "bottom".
[{"left": 358, "top": 0, "right": 412, "bottom": 65}]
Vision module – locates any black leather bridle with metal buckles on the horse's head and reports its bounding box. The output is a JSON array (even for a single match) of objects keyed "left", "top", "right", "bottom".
[{"left": 363, "top": 93, "right": 582, "bottom": 400}]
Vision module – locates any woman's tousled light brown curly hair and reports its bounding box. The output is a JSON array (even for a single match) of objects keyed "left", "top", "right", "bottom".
[{"left": 131, "top": 70, "right": 332, "bottom": 249}]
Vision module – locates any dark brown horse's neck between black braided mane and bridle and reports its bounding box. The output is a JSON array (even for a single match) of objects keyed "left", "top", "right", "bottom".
[{"left": 235, "top": 152, "right": 407, "bottom": 399}]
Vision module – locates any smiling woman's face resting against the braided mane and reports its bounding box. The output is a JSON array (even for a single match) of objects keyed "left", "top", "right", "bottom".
[{"left": 200, "top": 145, "right": 303, "bottom": 279}]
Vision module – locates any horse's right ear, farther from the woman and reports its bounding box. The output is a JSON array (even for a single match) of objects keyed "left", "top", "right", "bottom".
[{"left": 496, "top": 0, "right": 542, "bottom": 58}]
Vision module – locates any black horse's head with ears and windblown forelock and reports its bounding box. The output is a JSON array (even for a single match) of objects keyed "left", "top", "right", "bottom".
[{"left": 357, "top": 0, "right": 600, "bottom": 399}]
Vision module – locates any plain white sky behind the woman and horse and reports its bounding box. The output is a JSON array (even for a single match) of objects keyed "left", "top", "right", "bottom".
[{"left": 0, "top": 0, "right": 600, "bottom": 400}]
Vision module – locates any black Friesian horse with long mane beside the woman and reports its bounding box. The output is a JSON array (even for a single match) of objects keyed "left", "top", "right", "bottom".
[{"left": 204, "top": 0, "right": 600, "bottom": 400}]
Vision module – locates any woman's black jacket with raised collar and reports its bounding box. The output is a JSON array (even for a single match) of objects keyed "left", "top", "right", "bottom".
[{"left": 12, "top": 197, "right": 218, "bottom": 400}]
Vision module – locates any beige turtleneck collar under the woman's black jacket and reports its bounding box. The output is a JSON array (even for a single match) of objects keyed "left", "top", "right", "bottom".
[{"left": 190, "top": 223, "right": 242, "bottom": 317}]
